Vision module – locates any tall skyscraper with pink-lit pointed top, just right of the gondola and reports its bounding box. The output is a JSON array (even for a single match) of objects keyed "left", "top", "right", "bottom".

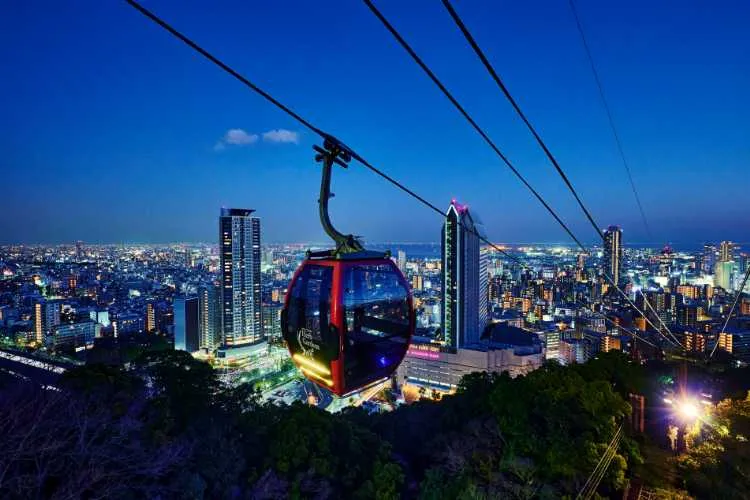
[{"left": 441, "top": 200, "right": 488, "bottom": 350}]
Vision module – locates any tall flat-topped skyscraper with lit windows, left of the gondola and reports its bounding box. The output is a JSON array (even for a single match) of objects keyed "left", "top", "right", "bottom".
[{"left": 219, "top": 208, "right": 263, "bottom": 348}]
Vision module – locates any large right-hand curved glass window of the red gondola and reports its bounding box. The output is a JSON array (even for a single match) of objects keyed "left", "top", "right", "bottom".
[{"left": 342, "top": 263, "right": 411, "bottom": 388}]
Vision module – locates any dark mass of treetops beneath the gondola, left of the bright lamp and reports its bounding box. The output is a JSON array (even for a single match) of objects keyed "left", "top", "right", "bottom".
[{"left": 0, "top": 351, "right": 638, "bottom": 500}]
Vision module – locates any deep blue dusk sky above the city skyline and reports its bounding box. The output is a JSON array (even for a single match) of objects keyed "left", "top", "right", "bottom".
[{"left": 0, "top": 0, "right": 750, "bottom": 243}]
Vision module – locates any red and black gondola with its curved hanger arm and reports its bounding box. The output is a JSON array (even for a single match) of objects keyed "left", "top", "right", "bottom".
[{"left": 281, "top": 137, "right": 415, "bottom": 396}]
